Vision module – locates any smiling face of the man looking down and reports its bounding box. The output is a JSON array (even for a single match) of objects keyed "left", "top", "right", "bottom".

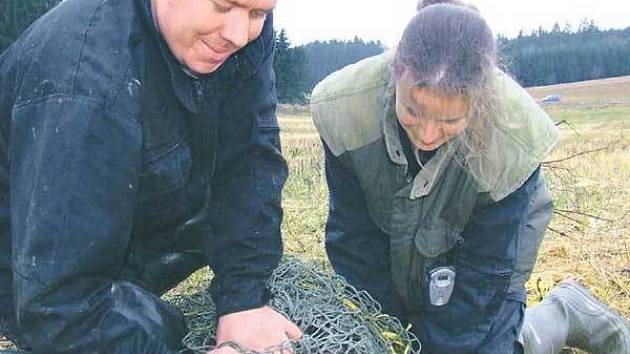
[{"left": 151, "top": 0, "right": 277, "bottom": 74}]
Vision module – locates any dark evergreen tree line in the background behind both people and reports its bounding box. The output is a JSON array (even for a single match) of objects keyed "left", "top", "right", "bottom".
[{"left": 0, "top": 0, "right": 630, "bottom": 104}]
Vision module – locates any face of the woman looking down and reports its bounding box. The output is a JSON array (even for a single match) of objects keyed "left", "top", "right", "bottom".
[{"left": 396, "top": 75, "right": 469, "bottom": 151}]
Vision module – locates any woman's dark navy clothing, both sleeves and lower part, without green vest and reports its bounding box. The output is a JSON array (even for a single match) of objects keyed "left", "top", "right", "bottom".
[{"left": 325, "top": 140, "right": 539, "bottom": 353}]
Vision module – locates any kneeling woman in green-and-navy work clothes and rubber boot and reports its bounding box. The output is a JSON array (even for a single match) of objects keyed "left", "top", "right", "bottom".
[{"left": 311, "top": 0, "right": 630, "bottom": 353}]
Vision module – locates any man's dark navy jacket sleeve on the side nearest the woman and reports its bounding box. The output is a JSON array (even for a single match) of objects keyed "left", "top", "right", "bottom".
[{"left": 205, "top": 14, "right": 288, "bottom": 316}]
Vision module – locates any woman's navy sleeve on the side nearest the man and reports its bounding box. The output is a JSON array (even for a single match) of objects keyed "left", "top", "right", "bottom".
[{"left": 323, "top": 143, "right": 399, "bottom": 315}]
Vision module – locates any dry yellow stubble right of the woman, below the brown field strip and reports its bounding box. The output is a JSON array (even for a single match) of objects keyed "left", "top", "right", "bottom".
[{"left": 529, "top": 117, "right": 630, "bottom": 317}]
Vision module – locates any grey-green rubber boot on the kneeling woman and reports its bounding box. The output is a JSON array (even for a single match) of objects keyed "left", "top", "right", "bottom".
[{"left": 521, "top": 280, "right": 630, "bottom": 354}]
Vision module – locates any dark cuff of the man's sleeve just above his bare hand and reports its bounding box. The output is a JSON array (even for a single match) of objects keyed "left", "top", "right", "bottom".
[{"left": 210, "top": 277, "right": 270, "bottom": 318}]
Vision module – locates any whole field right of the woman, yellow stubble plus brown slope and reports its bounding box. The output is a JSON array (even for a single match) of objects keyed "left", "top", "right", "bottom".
[{"left": 529, "top": 77, "right": 630, "bottom": 317}]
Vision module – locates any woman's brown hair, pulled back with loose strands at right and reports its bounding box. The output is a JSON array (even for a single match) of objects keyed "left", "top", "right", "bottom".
[{"left": 391, "top": 0, "right": 504, "bottom": 169}]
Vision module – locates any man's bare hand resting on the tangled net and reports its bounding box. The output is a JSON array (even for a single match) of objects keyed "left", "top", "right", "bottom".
[{"left": 209, "top": 306, "right": 302, "bottom": 354}]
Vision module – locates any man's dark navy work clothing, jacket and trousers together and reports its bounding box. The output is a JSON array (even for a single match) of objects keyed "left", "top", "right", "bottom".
[{"left": 0, "top": 0, "right": 287, "bottom": 354}]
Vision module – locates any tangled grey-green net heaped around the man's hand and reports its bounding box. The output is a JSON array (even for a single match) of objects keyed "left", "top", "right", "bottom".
[{"left": 171, "top": 259, "right": 420, "bottom": 354}]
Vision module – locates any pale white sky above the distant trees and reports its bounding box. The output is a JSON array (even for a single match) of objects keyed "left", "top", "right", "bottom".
[{"left": 274, "top": 0, "right": 630, "bottom": 46}]
